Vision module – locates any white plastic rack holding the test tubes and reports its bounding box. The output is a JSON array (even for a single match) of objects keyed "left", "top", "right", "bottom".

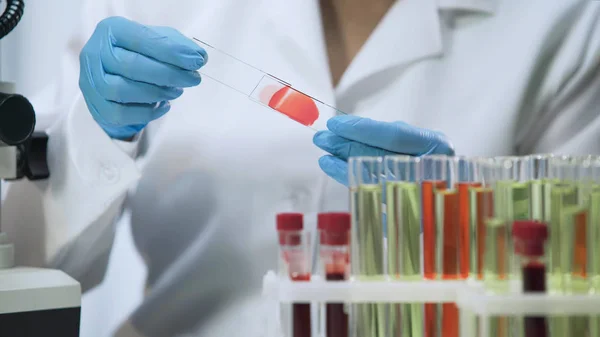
[{"left": 263, "top": 271, "right": 600, "bottom": 337}]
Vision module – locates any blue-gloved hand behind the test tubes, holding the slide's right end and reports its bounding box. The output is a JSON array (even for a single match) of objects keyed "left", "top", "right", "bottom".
[{"left": 313, "top": 115, "right": 454, "bottom": 186}]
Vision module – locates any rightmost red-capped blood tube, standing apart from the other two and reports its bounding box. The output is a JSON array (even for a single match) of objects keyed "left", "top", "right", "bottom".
[{"left": 512, "top": 221, "right": 548, "bottom": 337}]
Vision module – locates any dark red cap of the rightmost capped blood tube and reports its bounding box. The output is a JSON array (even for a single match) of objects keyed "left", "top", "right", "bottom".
[{"left": 512, "top": 220, "right": 548, "bottom": 256}]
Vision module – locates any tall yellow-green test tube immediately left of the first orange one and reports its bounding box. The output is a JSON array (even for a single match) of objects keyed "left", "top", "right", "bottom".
[{"left": 385, "top": 156, "right": 425, "bottom": 337}]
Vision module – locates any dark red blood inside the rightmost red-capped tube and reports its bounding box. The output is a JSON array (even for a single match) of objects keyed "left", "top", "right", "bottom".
[{"left": 523, "top": 262, "right": 548, "bottom": 337}]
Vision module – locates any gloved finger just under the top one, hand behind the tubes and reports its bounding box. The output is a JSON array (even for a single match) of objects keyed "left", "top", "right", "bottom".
[{"left": 313, "top": 131, "right": 394, "bottom": 160}]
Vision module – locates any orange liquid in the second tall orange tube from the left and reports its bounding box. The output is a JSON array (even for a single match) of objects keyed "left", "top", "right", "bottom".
[{"left": 457, "top": 183, "right": 481, "bottom": 279}]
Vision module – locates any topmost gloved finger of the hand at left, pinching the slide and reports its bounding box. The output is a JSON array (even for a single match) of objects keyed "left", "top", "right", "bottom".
[{"left": 98, "top": 17, "right": 207, "bottom": 70}]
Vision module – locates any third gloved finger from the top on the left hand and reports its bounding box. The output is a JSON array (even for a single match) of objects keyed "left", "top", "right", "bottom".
[{"left": 94, "top": 74, "right": 183, "bottom": 103}]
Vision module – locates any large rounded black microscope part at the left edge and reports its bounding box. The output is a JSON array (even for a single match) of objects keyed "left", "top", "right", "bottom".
[{"left": 0, "top": 93, "right": 35, "bottom": 145}]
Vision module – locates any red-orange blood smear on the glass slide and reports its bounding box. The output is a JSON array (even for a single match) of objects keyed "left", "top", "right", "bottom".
[{"left": 260, "top": 86, "right": 319, "bottom": 126}]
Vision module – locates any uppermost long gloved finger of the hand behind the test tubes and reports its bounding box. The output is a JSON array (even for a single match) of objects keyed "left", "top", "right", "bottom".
[{"left": 327, "top": 115, "right": 454, "bottom": 155}]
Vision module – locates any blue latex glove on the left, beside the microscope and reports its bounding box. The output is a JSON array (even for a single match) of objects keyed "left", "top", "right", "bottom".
[{"left": 79, "top": 17, "right": 207, "bottom": 139}]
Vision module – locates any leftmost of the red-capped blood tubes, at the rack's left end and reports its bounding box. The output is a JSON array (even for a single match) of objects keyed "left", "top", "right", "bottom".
[{"left": 277, "top": 213, "right": 312, "bottom": 337}]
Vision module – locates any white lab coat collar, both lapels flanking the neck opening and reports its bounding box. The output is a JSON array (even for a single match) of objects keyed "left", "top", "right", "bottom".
[{"left": 263, "top": 0, "right": 499, "bottom": 102}]
